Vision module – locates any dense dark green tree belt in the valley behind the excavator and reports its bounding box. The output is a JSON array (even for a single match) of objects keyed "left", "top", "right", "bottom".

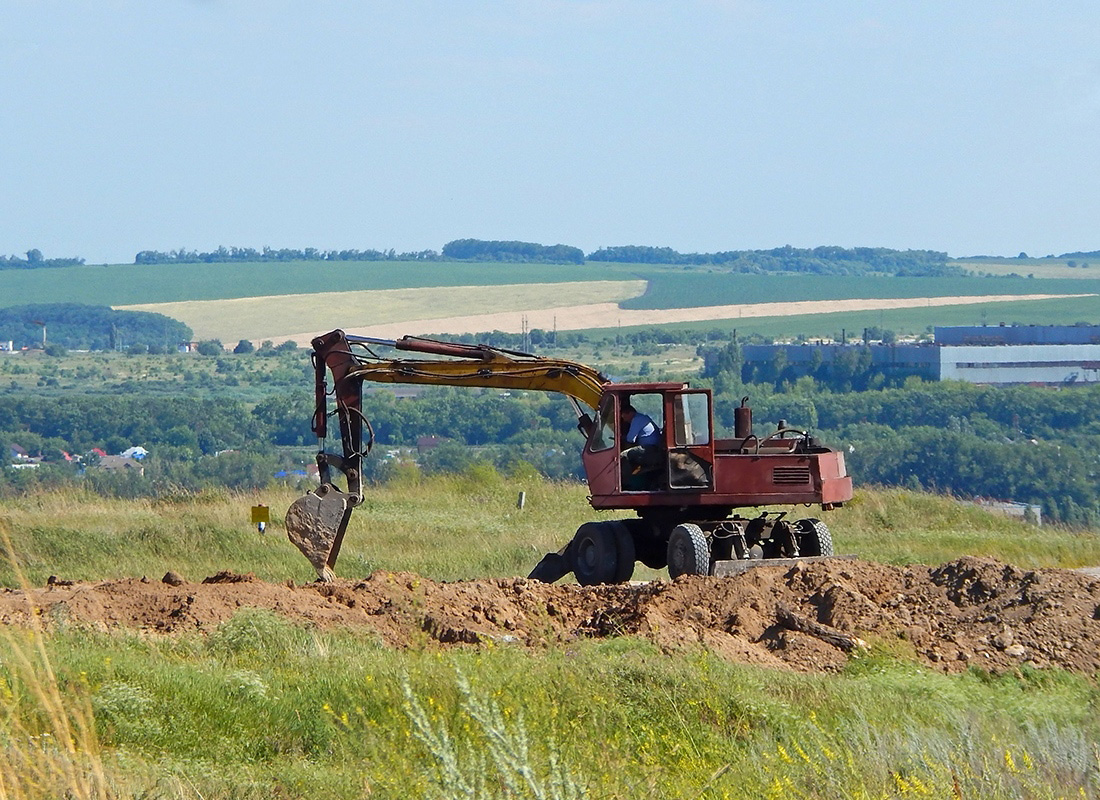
[{"left": 0, "top": 375, "right": 1100, "bottom": 526}]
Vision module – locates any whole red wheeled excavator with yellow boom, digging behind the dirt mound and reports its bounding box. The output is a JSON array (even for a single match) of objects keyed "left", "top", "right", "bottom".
[{"left": 286, "top": 330, "right": 851, "bottom": 585}]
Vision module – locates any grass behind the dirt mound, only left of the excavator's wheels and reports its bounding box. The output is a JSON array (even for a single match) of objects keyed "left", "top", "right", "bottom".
[{"left": 0, "top": 472, "right": 598, "bottom": 585}]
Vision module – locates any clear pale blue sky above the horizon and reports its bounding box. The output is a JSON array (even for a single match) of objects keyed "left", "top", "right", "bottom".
[{"left": 0, "top": 0, "right": 1100, "bottom": 263}]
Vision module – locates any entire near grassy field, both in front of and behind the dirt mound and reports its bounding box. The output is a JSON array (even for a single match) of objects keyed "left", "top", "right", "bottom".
[{"left": 0, "top": 472, "right": 1100, "bottom": 800}]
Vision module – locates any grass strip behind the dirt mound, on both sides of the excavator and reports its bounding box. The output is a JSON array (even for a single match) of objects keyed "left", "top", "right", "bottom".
[{"left": 0, "top": 475, "right": 1100, "bottom": 585}]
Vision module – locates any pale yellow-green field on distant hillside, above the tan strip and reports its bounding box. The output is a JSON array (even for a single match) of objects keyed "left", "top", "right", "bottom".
[{"left": 119, "top": 281, "right": 646, "bottom": 344}]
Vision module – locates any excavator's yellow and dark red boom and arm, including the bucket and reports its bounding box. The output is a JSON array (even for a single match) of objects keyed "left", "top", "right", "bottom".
[{"left": 286, "top": 330, "right": 608, "bottom": 581}]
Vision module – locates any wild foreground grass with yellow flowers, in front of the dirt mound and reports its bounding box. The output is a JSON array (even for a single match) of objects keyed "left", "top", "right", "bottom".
[{"left": 0, "top": 610, "right": 1100, "bottom": 799}]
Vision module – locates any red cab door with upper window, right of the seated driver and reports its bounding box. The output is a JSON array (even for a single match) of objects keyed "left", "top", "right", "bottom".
[{"left": 664, "top": 390, "right": 714, "bottom": 492}]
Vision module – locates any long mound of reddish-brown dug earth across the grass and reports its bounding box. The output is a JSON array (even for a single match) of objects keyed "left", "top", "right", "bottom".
[{"left": 0, "top": 558, "right": 1100, "bottom": 673}]
